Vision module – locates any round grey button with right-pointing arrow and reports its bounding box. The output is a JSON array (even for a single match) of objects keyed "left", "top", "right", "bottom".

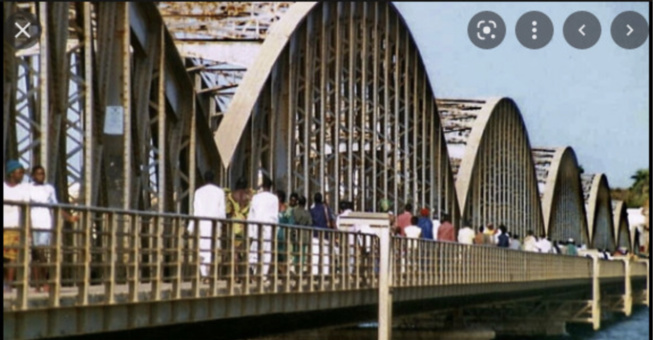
[{"left": 610, "top": 11, "right": 649, "bottom": 50}]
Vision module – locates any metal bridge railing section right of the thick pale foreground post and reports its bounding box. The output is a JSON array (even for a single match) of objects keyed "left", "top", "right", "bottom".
[{"left": 392, "top": 237, "right": 592, "bottom": 287}]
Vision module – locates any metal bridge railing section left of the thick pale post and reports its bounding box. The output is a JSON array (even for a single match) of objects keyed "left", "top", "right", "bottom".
[{"left": 3, "top": 201, "right": 379, "bottom": 310}]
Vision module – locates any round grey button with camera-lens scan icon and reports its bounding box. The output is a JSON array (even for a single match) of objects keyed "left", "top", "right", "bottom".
[{"left": 467, "top": 11, "right": 506, "bottom": 50}]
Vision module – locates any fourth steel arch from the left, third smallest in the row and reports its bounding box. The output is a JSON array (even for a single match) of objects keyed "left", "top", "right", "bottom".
[{"left": 533, "top": 147, "right": 589, "bottom": 244}]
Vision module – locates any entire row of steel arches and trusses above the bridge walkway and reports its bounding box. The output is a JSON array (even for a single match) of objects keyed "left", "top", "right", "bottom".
[{"left": 3, "top": 2, "right": 623, "bottom": 249}]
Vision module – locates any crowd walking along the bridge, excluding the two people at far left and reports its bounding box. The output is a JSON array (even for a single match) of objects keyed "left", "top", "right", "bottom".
[{"left": 190, "top": 171, "right": 620, "bottom": 284}]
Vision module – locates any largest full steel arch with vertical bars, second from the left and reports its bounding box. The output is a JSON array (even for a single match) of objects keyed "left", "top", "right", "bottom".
[{"left": 216, "top": 2, "right": 458, "bottom": 217}]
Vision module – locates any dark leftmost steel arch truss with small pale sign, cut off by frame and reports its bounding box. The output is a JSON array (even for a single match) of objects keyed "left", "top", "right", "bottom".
[{"left": 3, "top": 2, "right": 220, "bottom": 212}]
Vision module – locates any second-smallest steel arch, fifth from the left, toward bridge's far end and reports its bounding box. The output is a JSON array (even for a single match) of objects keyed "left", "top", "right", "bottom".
[{"left": 581, "top": 174, "right": 616, "bottom": 251}]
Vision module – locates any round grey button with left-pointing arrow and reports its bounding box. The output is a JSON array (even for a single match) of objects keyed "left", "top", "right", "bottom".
[{"left": 562, "top": 11, "right": 601, "bottom": 50}]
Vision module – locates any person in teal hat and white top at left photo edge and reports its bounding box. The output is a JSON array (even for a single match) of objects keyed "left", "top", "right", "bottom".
[{"left": 2, "top": 160, "right": 29, "bottom": 292}]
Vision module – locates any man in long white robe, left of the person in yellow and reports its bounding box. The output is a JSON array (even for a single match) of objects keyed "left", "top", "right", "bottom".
[{"left": 188, "top": 170, "right": 227, "bottom": 277}]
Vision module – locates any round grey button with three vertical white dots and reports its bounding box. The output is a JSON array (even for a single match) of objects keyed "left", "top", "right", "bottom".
[{"left": 515, "top": 11, "right": 553, "bottom": 50}]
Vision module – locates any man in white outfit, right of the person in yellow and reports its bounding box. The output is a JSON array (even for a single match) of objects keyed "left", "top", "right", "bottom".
[{"left": 247, "top": 175, "right": 279, "bottom": 275}]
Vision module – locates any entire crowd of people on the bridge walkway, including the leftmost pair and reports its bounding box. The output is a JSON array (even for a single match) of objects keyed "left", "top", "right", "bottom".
[{"left": 3, "top": 161, "right": 640, "bottom": 291}]
